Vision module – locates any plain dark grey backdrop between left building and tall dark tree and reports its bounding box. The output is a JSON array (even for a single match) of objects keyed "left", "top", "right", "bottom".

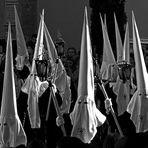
[{"left": 39, "top": 0, "right": 88, "bottom": 50}]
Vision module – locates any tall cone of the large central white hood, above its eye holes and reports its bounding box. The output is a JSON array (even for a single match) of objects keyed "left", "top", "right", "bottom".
[{"left": 78, "top": 8, "right": 94, "bottom": 98}]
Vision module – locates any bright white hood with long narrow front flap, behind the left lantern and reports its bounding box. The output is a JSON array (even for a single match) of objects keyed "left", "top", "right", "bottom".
[{"left": 22, "top": 10, "right": 44, "bottom": 128}]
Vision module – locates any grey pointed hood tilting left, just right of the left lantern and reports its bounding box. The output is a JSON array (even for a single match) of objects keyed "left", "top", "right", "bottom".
[{"left": 44, "top": 18, "right": 71, "bottom": 113}]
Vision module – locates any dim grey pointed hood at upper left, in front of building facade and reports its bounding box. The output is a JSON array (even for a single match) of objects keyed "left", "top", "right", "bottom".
[{"left": 14, "top": 6, "right": 28, "bottom": 70}]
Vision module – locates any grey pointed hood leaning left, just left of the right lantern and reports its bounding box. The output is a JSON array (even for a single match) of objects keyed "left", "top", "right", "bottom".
[{"left": 100, "top": 15, "right": 116, "bottom": 80}]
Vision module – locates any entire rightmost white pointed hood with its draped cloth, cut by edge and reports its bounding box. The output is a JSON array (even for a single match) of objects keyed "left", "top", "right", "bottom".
[{"left": 127, "top": 12, "right": 148, "bottom": 132}]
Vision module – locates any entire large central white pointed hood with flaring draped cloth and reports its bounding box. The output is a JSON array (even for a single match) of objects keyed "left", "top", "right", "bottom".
[{"left": 70, "top": 7, "right": 106, "bottom": 143}]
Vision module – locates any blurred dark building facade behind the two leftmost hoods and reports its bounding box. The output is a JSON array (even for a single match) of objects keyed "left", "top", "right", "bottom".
[{"left": 0, "top": 0, "right": 38, "bottom": 40}]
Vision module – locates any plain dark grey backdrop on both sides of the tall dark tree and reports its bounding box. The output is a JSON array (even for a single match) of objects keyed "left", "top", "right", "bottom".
[{"left": 39, "top": 0, "right": 148, "bottom": 49}]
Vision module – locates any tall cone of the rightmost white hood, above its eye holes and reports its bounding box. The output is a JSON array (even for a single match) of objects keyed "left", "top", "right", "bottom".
[{"left": 132, "top": 13, "right": 148, "bottom": 91}]
